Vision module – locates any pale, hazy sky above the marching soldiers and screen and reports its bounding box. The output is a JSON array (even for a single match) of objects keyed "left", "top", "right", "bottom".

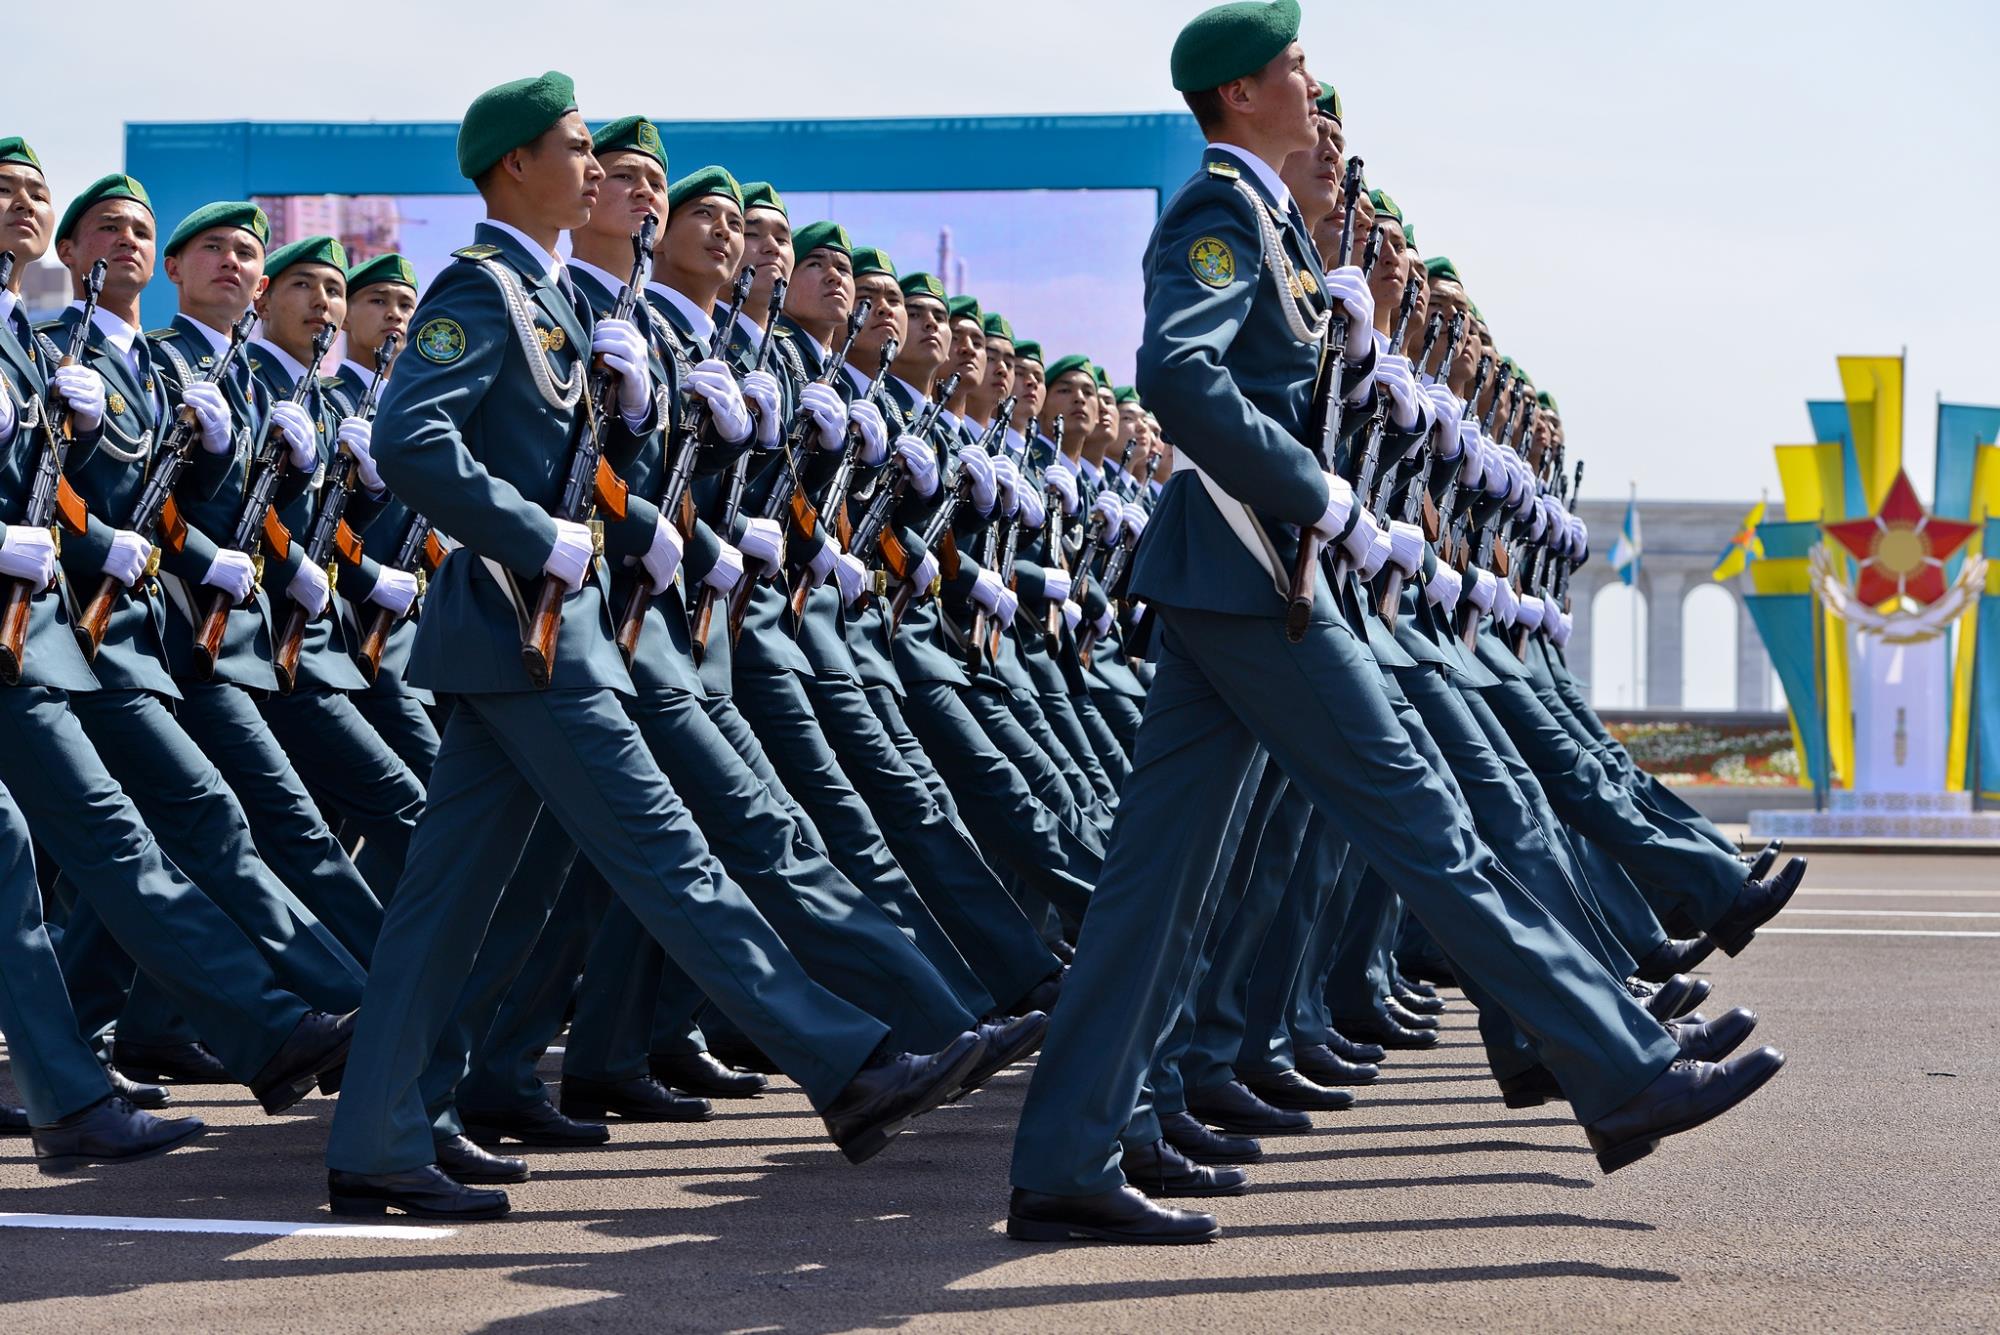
[{"left": 15, "top": 0, "right": 2000, "bottom": 504}]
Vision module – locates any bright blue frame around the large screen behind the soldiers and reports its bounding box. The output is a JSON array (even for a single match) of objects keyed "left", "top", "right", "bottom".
[{"left": 137, "top": 112, "right": 1202, "bottom": 326}]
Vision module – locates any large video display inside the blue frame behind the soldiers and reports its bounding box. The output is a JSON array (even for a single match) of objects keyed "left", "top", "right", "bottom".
[{"left": 258, "top": 190, "right": 1158, "bottom": 382}]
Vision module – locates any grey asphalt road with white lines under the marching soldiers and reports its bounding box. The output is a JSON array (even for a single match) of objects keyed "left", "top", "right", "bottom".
[{"left": 0, "top": 855, "right": 2000, "bottom": 1335}]
